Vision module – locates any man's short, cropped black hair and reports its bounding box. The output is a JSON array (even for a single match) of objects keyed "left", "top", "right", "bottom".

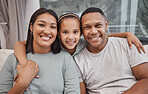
[{"left": 80, "top": 7, "right": 106, "bottom": 20}]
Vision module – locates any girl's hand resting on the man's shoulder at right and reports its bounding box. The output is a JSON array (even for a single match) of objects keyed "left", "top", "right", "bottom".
[{"left": 126, "top": 32, "right": 145, "bottom": 53}]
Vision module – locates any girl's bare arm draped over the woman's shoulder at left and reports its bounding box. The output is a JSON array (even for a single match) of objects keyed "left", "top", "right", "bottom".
[{"left": 14, "top": 41, "right": 27, "bottom": 66}]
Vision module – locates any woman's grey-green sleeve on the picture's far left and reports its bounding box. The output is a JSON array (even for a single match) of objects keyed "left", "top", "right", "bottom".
[{"left": 0, "top": 54, "right": 15, "bottom": 94}]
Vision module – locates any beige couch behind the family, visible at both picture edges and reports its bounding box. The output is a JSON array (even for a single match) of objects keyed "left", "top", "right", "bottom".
[{"left": 0, "top": 45, "right": 148, "bottom": 70}]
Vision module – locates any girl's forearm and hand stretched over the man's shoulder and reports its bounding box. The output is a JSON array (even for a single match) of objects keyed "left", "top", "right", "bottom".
[{"left": 108, "top": 32, "right": 145, "bottom": 53}]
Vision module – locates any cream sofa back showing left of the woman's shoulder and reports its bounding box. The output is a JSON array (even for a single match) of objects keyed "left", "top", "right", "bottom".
[{"left": 0, "top": 49, "right": 14, "bottom": 70}]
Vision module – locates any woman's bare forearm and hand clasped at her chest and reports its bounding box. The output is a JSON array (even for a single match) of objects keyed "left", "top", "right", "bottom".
[{"left": 8, "top": 60, "right": 39, "bottom": 94}]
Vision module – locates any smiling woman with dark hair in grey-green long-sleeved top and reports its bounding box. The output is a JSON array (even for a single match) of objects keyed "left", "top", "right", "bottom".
[{"left": 0, "top": 8, "right": 80, "bottom": 94}]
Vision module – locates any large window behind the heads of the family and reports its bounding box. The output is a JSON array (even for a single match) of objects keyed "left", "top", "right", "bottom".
[{"left": 40, "top": 0, "right": 148, "bottom": 44}]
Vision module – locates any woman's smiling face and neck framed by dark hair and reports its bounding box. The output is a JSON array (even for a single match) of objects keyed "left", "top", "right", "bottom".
[{"left": 30, "top": 13, "right": 57, "bottom": 51}]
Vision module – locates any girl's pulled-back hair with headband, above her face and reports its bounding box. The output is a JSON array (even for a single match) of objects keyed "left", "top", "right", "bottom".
[{"left": 58, "top": 13, "right": 81, "bottom": 32}]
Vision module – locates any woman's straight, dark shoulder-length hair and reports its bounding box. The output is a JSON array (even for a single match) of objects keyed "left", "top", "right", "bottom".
[{"left": 26, "top": 8, "right": 61, "bottom": 53}]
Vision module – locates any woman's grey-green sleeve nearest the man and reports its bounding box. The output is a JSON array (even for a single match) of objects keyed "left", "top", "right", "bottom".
[{"left": 64, "top": 56, "right": 80, "bottom": 94}]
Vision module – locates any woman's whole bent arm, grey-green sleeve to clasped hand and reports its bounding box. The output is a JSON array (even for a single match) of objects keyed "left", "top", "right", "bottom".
[{"left": 0, "top": 54, "right": 39, "bottom": 94}]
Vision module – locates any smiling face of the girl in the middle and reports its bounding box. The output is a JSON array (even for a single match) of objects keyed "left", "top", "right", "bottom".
[{"left": 59, "top": 18, "right": 81, "bottom": 50}]
